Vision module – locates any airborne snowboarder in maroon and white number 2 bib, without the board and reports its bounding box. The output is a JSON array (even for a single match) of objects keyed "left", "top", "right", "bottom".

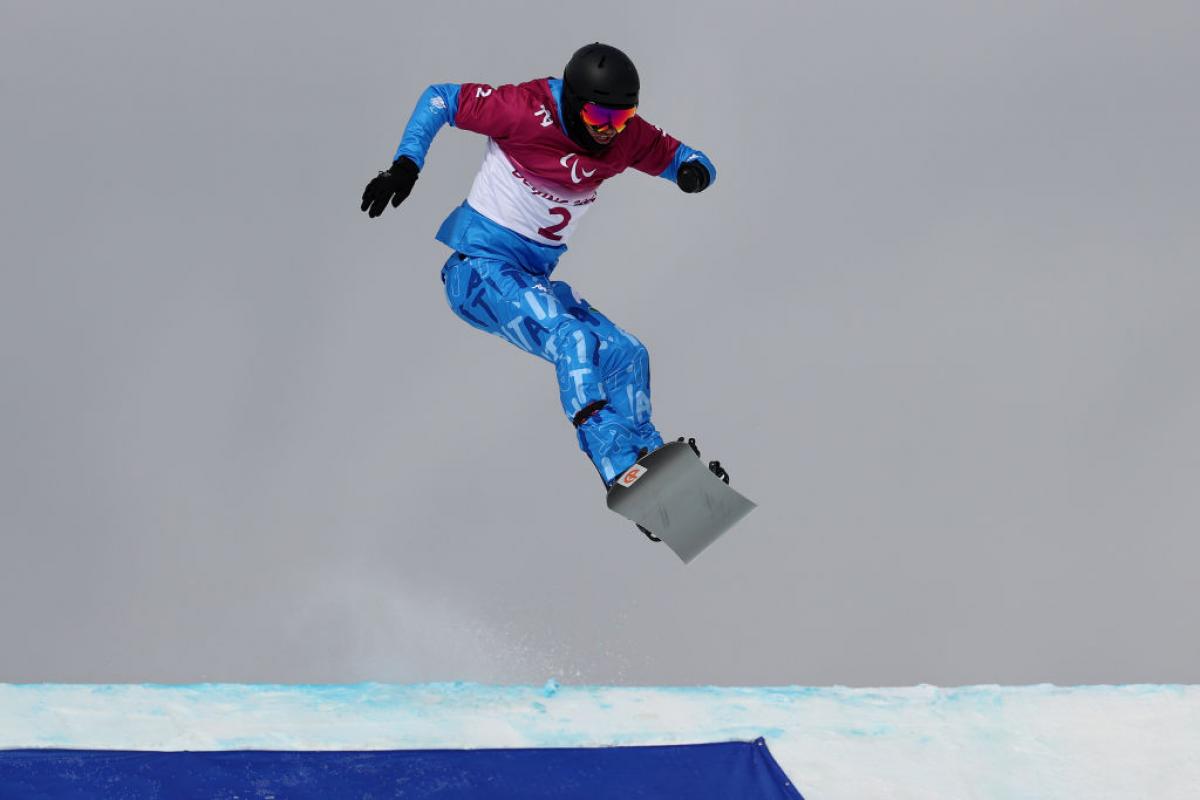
[{"left": 361, "top": 43, "right": 727, "bottom": 520}]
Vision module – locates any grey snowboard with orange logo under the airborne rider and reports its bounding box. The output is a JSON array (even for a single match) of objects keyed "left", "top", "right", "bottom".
[{"left": 608, "top": 441, "right": 756, "bottom": 564}]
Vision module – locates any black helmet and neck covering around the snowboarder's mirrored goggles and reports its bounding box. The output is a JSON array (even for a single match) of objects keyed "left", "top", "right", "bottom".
[{"left": 563, "top": 42, "right": 641, "bottom": 152}]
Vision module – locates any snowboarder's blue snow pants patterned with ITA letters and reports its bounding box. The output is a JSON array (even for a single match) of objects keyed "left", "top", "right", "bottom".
[{"left": 442, "top": 253, "right": 662, "bottom": 485}]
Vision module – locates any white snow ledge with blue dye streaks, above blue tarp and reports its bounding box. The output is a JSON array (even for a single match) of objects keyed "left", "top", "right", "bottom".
[{"left": 0, "top": 680, "right": 1200, "bottom": 800}]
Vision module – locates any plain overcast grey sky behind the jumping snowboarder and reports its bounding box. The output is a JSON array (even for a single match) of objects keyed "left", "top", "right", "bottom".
[{"left": 0, "top": 0, "right": 1200, "bottom": 685}]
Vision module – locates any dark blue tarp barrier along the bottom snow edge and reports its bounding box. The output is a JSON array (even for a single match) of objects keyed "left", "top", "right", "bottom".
[{"left": 0, "top": 739, "right": 803, "bottom": 800}]
